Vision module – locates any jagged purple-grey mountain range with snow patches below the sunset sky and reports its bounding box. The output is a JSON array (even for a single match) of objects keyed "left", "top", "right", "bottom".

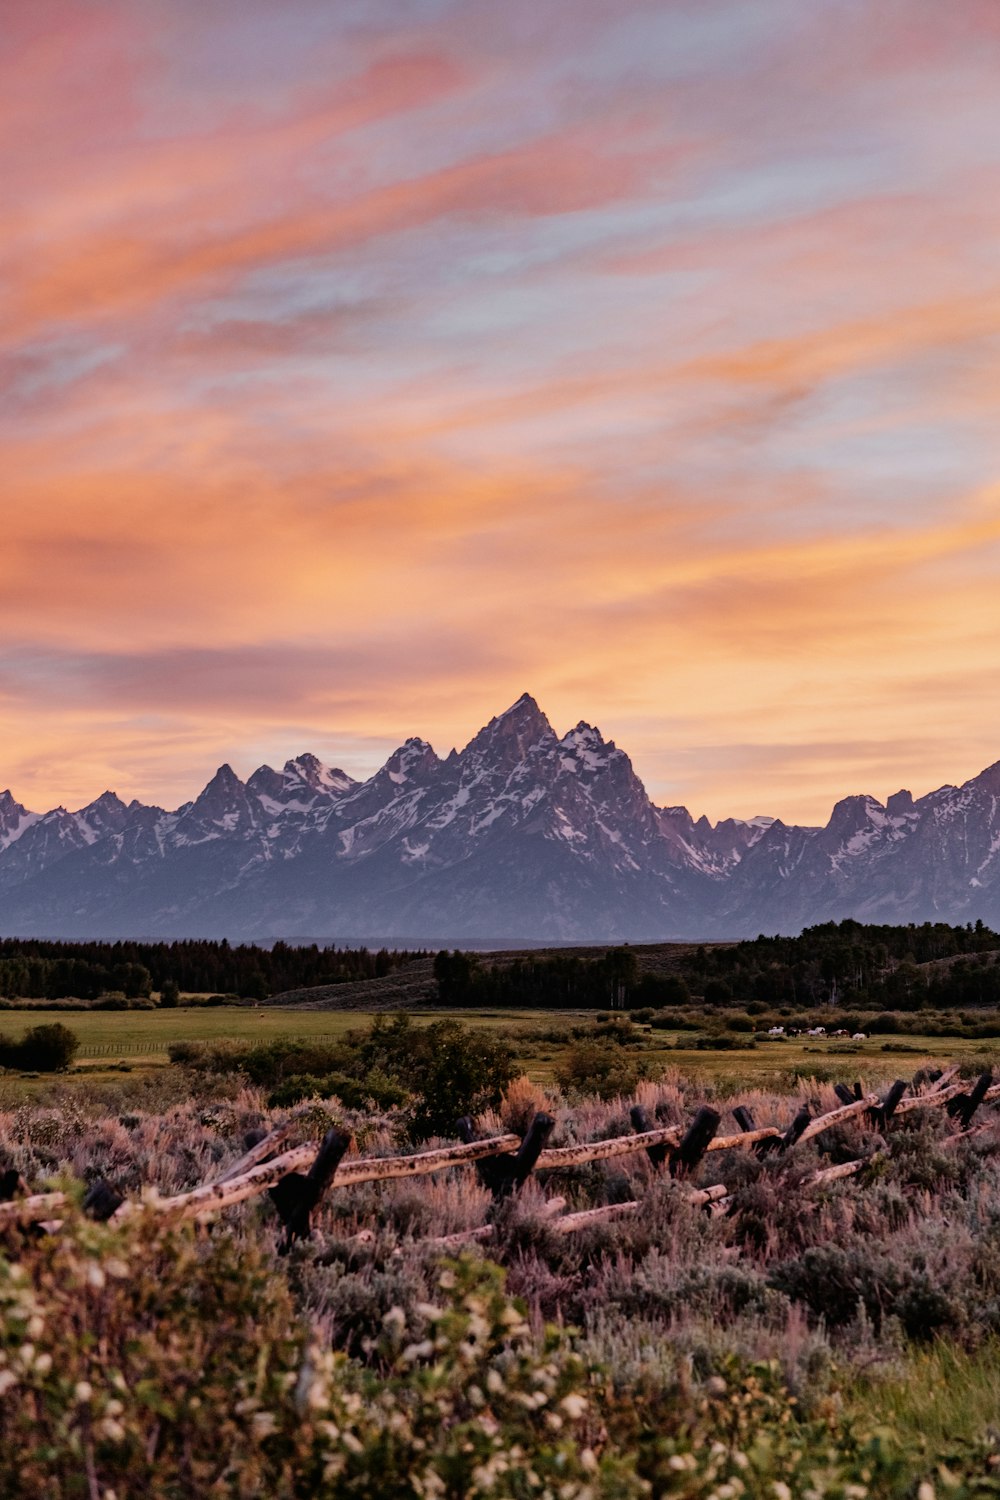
[{"left": 0, "top": 693, "right": 1000, "bottom": 942}]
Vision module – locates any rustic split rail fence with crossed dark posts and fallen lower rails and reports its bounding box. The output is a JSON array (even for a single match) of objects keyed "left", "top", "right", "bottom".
[{"left": 0, "top": 1067, "right": 1000, "bottom": 1248}]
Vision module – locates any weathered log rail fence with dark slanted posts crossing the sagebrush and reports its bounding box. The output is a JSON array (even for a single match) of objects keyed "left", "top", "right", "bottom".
[{"left": 0, "top": 1068, "right": 1000, "bottom": 1239}]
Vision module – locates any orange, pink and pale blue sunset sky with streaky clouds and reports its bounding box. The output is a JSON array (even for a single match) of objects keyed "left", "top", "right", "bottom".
[{"left": 0, "top": 0, "right": 1000, "bottom": 822}]
